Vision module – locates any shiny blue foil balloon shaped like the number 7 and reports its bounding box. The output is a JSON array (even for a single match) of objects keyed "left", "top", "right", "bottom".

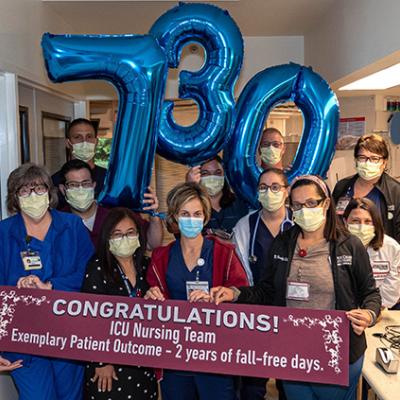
[{"left": 42, "top": 33, "right": 168, "bottom": 210}]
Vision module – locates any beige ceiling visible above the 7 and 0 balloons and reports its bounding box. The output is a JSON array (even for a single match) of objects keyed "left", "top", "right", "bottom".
[{"left": 42, "top": 0, "right": 335, "bottom": 36}]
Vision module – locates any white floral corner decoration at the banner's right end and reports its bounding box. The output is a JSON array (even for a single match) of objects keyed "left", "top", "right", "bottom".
[{"left": 284, "top": 315, "right": 343, "bottom": 374}]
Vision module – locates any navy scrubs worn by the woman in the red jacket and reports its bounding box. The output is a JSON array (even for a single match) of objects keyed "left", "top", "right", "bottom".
[{"left": 161, "top": 238, "right": 236, "bottom": 400}]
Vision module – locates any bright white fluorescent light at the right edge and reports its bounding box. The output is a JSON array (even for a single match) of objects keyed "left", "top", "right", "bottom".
[{"left": 339, "top": 63, "right": 400, "bottom": 90}]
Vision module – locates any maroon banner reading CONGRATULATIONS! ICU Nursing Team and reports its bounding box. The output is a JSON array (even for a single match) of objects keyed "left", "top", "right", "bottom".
[{"left": 0, "top": 286, "right": 349, "bottom": 385}]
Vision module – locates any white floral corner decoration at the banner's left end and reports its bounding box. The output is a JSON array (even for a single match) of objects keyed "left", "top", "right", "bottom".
[{"left": 0, "top": 290, "right": 47, "bottom": 340}]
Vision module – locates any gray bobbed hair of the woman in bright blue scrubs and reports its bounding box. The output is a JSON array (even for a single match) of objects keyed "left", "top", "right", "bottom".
[{"left": 7, "top": 163, "right": 58, "bottom": 214}]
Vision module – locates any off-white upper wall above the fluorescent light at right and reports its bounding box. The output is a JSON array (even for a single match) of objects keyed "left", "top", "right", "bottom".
[{"left": 305, "top": 0, "right": 400, "bottom": 82}]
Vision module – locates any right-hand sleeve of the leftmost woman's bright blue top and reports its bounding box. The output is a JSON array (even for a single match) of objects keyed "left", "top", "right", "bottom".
[{"left": 50, "top": 218, "right": 94, "bottom": 292}]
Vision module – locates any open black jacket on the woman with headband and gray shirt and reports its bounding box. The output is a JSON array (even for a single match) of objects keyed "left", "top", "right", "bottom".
[{"left": 238, "top": 225, "right": 381, "bottom": 363}]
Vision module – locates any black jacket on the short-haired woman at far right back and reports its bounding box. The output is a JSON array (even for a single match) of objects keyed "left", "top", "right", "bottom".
[{"left": 332, "top": 172, "right": 400, "bottom": 243}]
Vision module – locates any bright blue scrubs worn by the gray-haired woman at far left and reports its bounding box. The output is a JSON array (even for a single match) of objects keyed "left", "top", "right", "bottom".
[{"left": 0, "top": 210, "right": 94, "bottom": 400}]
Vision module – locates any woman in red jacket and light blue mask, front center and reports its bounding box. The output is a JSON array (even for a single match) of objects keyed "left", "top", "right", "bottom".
[{"left": 145, "top": 183, "right": 248, "bottom": 400}]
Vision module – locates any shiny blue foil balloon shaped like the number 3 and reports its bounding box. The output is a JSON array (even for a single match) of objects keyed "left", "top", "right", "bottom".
[{"left": 150, "top": 3, "right": 243, "bottom": 165}]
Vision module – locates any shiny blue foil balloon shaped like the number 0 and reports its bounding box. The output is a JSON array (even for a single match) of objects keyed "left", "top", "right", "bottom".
[{"left": 224, "top": 63, "right": 339, "bottom": 208}]
